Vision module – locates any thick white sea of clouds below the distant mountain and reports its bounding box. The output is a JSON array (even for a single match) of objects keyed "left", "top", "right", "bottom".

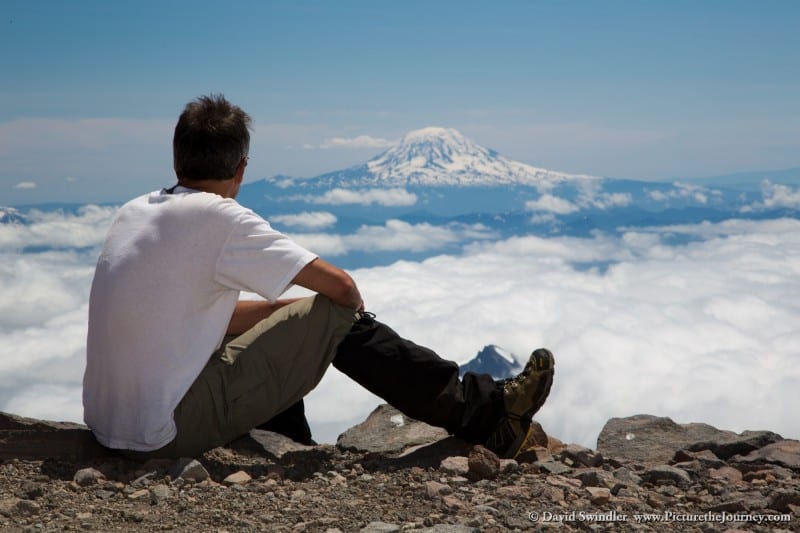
[{"left": 0, "top": 206, "right": 800, "bottom": 446}]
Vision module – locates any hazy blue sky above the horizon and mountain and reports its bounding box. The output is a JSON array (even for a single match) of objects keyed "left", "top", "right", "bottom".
[{"left": 0, "top": 0, "right": 800, "bottom": 204}]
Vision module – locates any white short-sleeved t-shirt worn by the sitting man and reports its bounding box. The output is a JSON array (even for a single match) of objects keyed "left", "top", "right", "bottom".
[{"left": 83, "top": 188, "right": 316, "bottom": 451}]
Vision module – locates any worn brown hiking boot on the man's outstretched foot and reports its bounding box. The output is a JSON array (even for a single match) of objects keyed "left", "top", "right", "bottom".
[{"left": 486, "top": 348, "right": 555, "bottom": 459}]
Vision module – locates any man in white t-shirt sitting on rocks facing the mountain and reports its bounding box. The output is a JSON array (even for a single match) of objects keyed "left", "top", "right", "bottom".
[{"left": 83, "top": 95, "right": 554, "bottom": 459}]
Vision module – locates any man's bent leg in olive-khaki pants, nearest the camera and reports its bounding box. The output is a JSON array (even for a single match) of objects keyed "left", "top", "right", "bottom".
[{"left": 143, "top": 295, "right": 356, "bottom": 457}]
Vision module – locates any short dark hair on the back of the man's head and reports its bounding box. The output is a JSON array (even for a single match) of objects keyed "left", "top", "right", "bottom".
[{"left": 172, "top": 94, "right": 251, "bottom": 180}]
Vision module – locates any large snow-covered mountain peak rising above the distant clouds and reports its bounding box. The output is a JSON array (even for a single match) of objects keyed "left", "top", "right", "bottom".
[{"left": 296, "top": 127, "right": 588, "bottom": 188}]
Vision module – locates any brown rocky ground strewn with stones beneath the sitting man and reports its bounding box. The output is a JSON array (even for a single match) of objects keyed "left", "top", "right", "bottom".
[{"left": 0, "top": 406, "right": 800, "bottom": 532}]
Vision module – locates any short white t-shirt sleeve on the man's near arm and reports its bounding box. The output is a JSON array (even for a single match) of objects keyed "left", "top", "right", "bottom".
[{"left": 216, "top": 211, "right": 317, "bottom": 301}]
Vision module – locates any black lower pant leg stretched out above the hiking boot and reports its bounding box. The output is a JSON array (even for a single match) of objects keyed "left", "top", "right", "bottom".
[{"left": 333, "top": 316, "right": 503, "bottom": 443}]
